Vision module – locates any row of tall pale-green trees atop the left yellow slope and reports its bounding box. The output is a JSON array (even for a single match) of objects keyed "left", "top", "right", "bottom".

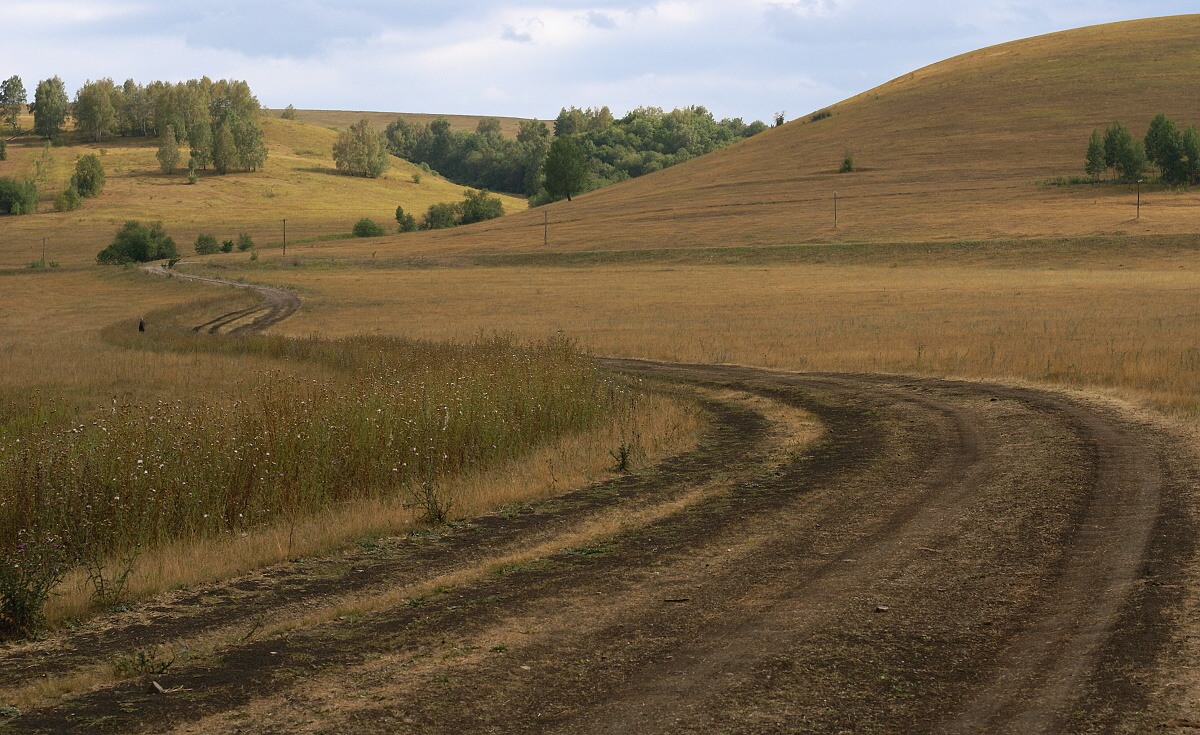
[{"left": 0, "top": 77, "right": 266, "bottom": 173}]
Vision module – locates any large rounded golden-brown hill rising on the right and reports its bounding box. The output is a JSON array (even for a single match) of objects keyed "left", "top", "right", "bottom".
[{"left": 352, "top": 16, "right": 1200, "bottom": 252}]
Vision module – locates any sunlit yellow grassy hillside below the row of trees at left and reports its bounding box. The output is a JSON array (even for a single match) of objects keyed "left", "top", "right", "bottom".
[{"left": 0, "top": 116, "right": 526, "bottom": 268}]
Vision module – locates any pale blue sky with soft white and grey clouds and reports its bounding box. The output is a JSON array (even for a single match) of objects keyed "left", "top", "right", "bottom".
[{"left": 0, "top": 0, "right": 1200, "bottom": 121}]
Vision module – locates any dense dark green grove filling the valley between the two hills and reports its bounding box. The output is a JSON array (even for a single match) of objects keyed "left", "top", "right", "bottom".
[{"left": 384, "top": 107, "right": 767, "bottom": 203}]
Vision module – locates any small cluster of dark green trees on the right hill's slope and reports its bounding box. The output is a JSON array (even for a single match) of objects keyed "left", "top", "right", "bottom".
[{"left": 1084, "top": 113, "right": 1200, "bottom": 186}]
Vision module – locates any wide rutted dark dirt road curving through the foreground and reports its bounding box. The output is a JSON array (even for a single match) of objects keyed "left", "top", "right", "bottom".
[{"left": 0, "top": 350, "right": 1195, "bottom": 734}]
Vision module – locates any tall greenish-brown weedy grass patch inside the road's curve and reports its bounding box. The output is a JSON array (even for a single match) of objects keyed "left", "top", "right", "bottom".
[{"left": 0, "top": 334, "right": 631, "bottom": 627}]
